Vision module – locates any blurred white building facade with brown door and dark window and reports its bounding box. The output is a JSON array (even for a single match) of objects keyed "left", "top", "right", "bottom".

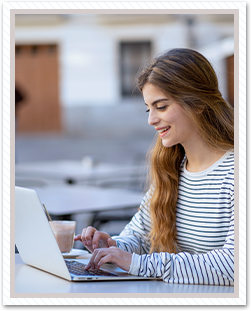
[{"left": 15, "top": 14, "right": 234, "bottom": 134}]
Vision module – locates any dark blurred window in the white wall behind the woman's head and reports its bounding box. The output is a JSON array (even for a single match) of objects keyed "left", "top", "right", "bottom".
[{"left": 120, "top": 41, "right": 151, "bottom": 97}]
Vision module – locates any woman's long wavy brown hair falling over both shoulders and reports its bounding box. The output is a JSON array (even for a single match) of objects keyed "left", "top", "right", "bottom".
[{"left": 137, "top": 48, "right": 234, "bottom": 253}]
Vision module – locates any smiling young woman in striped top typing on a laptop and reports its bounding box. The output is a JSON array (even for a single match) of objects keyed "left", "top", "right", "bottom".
[{"left": 75, "top": 49, "right": 234, "bottom": 285}]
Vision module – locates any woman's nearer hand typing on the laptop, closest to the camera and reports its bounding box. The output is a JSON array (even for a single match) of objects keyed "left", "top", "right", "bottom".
[{"left": 85, "top": 246, "right": 132, "bottom": 271}]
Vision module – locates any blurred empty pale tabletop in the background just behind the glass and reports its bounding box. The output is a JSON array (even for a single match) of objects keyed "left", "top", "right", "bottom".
[{"left": 34, "top": 184, "right": 143, "bottom": 216}]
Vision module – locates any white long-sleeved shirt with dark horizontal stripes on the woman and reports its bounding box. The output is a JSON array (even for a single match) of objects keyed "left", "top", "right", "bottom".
[{"left": 113, "top": 150, "right": 234, "bottom": 285}]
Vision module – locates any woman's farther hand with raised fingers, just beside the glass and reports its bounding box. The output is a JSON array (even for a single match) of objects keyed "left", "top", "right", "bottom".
[{"left": 74, "top": 227, "right": 117, "bottom": 253}]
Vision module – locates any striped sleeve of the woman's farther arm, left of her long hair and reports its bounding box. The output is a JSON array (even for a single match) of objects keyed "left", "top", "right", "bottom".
[{"left": 112, "top": 191, "right": 151, "bottom": 254}]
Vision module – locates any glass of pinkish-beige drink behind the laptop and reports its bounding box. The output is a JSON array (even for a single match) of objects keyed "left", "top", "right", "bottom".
[{"left": 49, "top": 220, "right": 76, "bottom": 253}]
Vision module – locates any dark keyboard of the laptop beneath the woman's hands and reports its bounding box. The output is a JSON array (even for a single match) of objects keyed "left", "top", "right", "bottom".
[{"left": 65, "top": 260, "right": 118, "bottom": 276}]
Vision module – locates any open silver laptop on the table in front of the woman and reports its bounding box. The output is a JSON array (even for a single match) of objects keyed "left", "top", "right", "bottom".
[{"left": 15, "top": 187, "right": 153, "bottom": 281}]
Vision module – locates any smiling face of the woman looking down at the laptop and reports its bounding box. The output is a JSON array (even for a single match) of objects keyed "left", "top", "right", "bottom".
[{"left": 143, "top": 83, "right": 198, "bottom": 149}]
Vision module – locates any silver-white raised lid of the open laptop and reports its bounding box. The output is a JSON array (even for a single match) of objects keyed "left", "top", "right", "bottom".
[{"left": 15, "top": 187, "right": 71, "bottom": 280}]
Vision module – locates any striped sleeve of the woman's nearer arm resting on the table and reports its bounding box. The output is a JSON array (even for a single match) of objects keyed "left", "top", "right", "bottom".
[{"left": 129, "top": 192, "right": 234, "bottom": 285}]
